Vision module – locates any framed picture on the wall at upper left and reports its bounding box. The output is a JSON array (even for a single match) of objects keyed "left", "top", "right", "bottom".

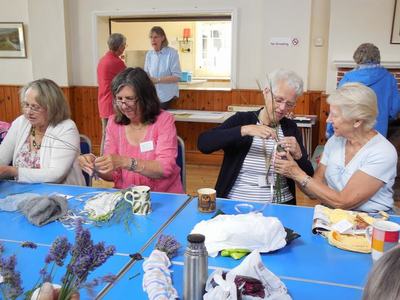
[{"left": 0, "top": 22, "right": 26, "bottom": 58}]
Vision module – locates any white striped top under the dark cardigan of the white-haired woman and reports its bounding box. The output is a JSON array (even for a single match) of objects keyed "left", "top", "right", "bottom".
[{"left": 228, "top": 127, "right": 293, "bottom": 203}]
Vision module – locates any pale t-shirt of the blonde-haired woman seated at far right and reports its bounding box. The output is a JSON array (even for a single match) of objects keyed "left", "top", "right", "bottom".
[{"left": 321, "top": 133, "right": 397, "bottom": 212}]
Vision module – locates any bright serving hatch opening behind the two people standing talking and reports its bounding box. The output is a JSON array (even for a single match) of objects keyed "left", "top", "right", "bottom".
[{"left": 109, "top": 15, "right": 232, "bottom": 81}]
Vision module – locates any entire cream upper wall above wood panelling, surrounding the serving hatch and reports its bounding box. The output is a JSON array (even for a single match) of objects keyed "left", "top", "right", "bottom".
[{"left": 0, "top": 0, "right": 400, "bottom": 92}]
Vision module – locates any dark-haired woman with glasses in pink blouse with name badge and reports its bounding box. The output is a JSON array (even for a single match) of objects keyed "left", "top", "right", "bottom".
[{"left": 79, "top": 68, "right": 183, "bottom": 193}]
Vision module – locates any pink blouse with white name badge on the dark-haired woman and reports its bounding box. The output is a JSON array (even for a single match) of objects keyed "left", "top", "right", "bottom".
[{"left": 104, "top": 111, "right": 183, "bottom": 193}]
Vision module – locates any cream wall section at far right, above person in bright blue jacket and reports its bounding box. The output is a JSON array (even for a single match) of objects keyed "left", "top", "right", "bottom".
[{"left": 326, "top": 0, "right": 400, "bottom": 93}]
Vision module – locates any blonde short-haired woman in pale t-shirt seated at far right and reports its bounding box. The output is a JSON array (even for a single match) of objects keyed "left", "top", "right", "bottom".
[{"left": 275, "top": 83, "right": 397, "bottom": 213}]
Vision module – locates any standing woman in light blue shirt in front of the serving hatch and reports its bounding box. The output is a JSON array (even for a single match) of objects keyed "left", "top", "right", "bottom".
[{"left": 144, "top": 26, "right": 181, "bottom": 109}]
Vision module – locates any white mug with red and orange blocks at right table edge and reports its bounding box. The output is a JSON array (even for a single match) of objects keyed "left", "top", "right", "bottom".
[{"left": 366, "top": 221, "right": 400, "bottom": 261}]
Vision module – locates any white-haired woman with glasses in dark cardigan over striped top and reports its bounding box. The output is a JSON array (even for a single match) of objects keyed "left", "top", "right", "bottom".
[{"left": 198, "top": 70, "right": 313, "bottom": 204}]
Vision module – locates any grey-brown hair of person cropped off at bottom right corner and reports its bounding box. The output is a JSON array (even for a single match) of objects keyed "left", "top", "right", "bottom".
[{"left": 362, "top": 246, "right": 400, "bottom": 300}]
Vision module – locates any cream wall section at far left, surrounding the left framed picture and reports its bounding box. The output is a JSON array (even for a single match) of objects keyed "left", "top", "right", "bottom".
[{"left": 0, "top": 0, "right": 69, "bottom": 86}]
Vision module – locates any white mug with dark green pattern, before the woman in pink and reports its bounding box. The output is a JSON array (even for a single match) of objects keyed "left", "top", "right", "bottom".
[{"left": 124, "top": 185, "right": 151, "bottom": 215}]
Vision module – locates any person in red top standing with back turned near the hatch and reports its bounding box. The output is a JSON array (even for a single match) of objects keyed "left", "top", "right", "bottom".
[{"left": 97, "top": 33, "right": 126, "bottom": 154}]
